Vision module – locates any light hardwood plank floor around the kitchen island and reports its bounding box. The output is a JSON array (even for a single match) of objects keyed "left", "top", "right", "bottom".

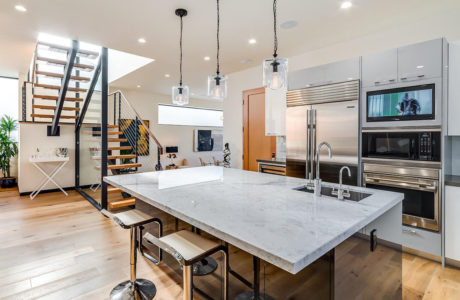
[{"left": 0, "top": 190, "right": 460, "bottom": 300}]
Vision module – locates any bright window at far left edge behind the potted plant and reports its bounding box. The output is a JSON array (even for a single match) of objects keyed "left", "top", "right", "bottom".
[{"left": 0, "top": 77, "right": 19, "bottom": 141}]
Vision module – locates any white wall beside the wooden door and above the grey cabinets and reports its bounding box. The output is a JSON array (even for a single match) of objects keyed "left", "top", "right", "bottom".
[{"left": 224, "top": 10, "right": 460, "bottom": 168}]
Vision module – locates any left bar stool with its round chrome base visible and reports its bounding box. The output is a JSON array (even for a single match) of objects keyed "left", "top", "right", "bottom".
[{"left": 110, "top": 209, "right": 163, "bottom": 300}]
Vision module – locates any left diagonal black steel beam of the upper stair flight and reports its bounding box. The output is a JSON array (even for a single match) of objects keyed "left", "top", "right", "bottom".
[{"left": 51, "top": 40, "right": 78, "bottom": 136}]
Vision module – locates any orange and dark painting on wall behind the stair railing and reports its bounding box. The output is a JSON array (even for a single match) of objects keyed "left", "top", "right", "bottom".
[{"left": 120, "top": 119, "right": 150, "bottom": 156}]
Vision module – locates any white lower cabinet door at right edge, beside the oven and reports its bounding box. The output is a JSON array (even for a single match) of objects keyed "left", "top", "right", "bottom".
[{"left": 445, "top": 186, "right": 460, "bottom": 261}]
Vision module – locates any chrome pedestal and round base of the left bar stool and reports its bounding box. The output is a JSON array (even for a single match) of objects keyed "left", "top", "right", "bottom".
[{"left": 110, "top": 227, "right": 157, "bottom": 300}]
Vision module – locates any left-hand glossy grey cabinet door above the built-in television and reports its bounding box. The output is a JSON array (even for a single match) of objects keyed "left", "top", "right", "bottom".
[{"left": 362, "top": 49, "right": 398, "bottom": 87}]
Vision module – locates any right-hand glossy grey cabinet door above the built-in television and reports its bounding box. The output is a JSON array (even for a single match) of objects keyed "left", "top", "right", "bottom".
[{"left": 398, "top": 39, "right": 442, "bottom": 82}]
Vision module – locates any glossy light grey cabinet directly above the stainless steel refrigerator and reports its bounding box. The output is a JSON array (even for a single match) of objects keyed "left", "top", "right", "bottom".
[{"left": 288, "top": 57, "right": 359, "bottom": 90}]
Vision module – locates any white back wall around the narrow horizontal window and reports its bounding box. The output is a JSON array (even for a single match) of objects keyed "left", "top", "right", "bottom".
[{"left": 112, "top": 88, "right": 223, "bottom": 167}]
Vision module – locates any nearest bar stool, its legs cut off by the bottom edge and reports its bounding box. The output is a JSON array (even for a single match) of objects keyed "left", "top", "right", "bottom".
[{"left": 144, "top": 230, "right": 228, "bottom": 300}]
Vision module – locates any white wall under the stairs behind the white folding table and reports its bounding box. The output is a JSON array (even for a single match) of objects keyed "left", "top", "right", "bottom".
[{"left": 18, "top": 123, "right": 75, "bottom": 193}]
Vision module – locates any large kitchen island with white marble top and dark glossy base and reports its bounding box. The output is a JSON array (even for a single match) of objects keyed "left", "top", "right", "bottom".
[{"left": 104, "top": 167, "right": 403, "bottom": 299}]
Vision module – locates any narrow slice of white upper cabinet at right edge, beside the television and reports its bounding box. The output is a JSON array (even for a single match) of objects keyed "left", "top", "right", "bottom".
[{"left": 447, "top": 41, "right": 460, "bottom": 135}]
